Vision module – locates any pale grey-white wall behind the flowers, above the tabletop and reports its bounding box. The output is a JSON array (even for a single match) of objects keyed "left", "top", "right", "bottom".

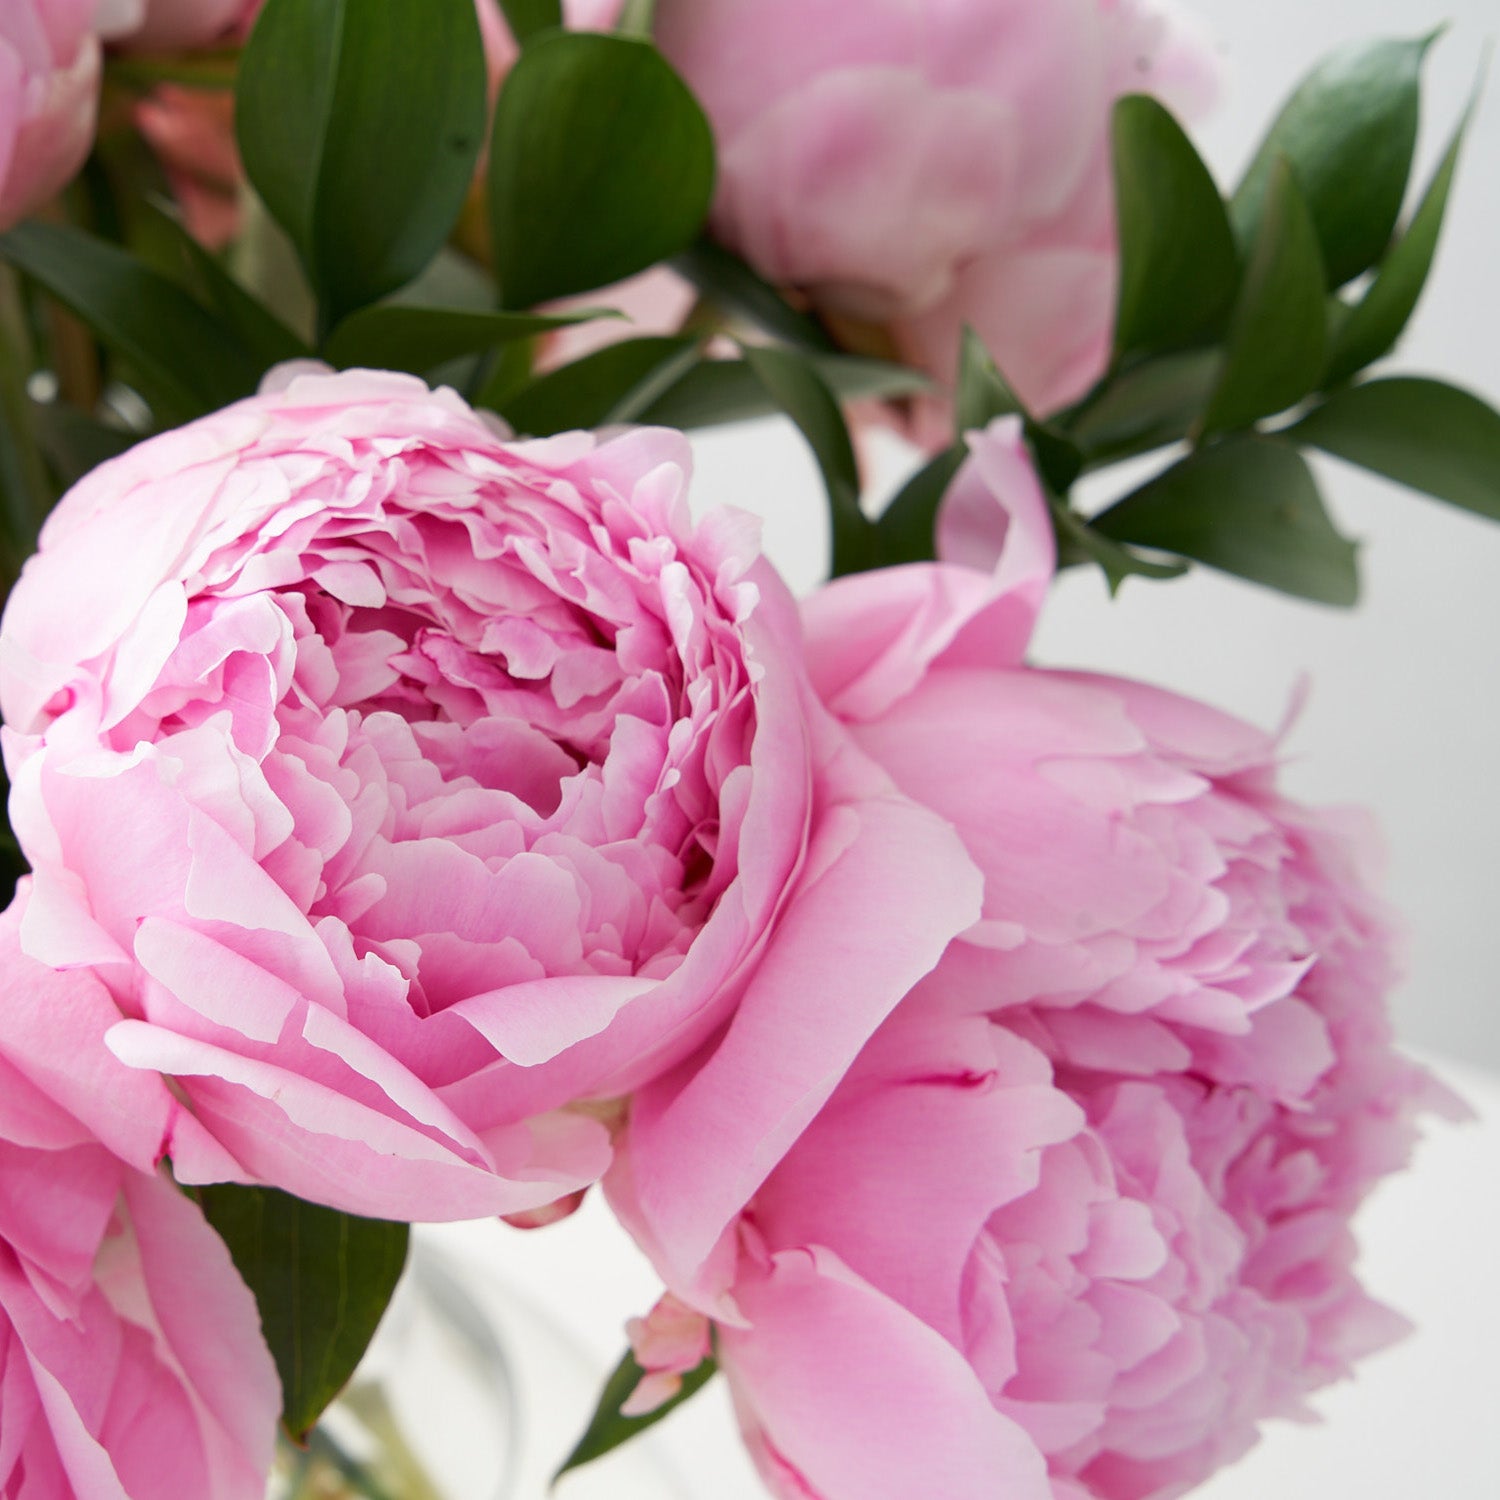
[{"left": 696, "top": 0, "right": 1500, "bottom": 1068}]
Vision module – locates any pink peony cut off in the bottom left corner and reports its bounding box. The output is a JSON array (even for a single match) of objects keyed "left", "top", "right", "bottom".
[{"left": 0, "top": 882, "right": 281, "bottom": 1500}]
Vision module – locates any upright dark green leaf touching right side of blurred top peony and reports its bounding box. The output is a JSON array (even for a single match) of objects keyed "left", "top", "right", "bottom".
[{"left": 1115, "top": 95, "right": 1239, "bottom": 360}]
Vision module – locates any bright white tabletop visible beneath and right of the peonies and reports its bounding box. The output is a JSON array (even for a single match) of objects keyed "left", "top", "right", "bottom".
[{"left": 417, "top": 1065, "right": 1500, "bottom": 1500}]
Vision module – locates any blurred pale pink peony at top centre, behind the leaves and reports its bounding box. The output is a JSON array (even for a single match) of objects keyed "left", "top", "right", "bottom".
[{"left": 656, "top": 0, "right": 1217, "bottom": 411}]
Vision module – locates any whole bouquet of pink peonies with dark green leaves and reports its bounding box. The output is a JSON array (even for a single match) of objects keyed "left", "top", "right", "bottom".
[{"left": 0, "top": 0, "right": 1500, "bottom": 1500}]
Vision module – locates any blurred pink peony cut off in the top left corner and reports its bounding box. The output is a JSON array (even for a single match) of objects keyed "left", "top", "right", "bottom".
[{"left": 0, "top": 0, "right": 99, "bottom": 230}]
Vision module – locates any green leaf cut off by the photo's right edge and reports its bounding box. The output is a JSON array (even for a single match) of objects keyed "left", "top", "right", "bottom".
[{"left": 1287, "top": 377, "right": 1500, "bottom": 521}]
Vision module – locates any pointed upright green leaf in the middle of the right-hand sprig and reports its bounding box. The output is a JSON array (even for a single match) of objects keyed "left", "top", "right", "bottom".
[{"left": 1203, "top": 161, "right": 1328, "bottom": 432}]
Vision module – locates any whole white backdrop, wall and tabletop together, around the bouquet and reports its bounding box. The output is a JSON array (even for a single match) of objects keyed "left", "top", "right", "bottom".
[{"left": 447, "top": 0, "right": 1500, "bottom": 1500}]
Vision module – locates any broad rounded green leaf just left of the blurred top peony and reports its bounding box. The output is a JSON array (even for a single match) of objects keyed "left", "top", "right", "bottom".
[{"left": 489, "top": 32, "right": 714, "bottom": 308}]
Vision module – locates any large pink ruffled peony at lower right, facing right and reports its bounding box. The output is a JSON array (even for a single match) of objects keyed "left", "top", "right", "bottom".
[{"left": 612, "top": 425, "right": 1440, "bottom": 1500}]
